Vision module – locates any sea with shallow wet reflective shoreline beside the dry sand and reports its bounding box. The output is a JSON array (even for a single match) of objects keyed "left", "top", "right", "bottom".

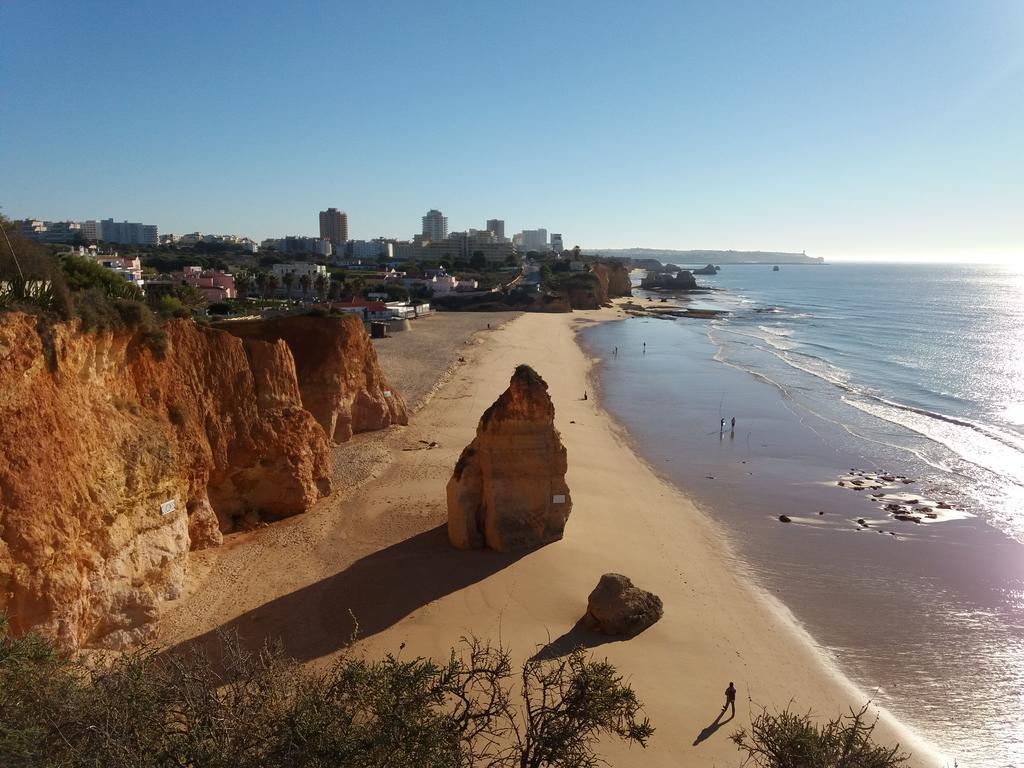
[{"left": 584, "top": 264, "right": 1024, "bottom": 768}]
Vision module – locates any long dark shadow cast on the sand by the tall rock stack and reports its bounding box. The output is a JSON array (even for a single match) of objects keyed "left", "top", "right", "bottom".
[{"left": 168, "top": 524, "right": 531, "bottom": 662}]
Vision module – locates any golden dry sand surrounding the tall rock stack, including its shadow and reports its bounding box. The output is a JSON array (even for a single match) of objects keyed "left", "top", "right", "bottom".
[{"left": 162, "top": 309, "right": 941, "bottom": 766}]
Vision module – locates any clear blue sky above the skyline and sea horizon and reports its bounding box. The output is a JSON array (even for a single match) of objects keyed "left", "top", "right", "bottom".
[{"left": 0, "top": 0, "right": 1024, "bottom": 260}]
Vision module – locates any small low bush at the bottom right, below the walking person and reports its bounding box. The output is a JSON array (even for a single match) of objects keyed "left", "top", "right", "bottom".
[{"left": 732, "top": 705, "right": 909, "bottom": 768}]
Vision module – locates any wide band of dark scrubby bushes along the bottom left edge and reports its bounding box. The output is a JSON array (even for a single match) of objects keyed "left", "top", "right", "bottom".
[{"left": 0, "top": 620, "right": 653, "bottom": 768}]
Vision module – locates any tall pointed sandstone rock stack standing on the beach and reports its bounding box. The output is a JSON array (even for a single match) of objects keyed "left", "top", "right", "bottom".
[{"left": 447, "top": 366, "right": 572, "bottom": 552}]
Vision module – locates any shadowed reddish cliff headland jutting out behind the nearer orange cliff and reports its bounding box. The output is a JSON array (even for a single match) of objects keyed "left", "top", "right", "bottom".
[{"left": 218, "top": 314, "right": 409, "bottom": 442}]
